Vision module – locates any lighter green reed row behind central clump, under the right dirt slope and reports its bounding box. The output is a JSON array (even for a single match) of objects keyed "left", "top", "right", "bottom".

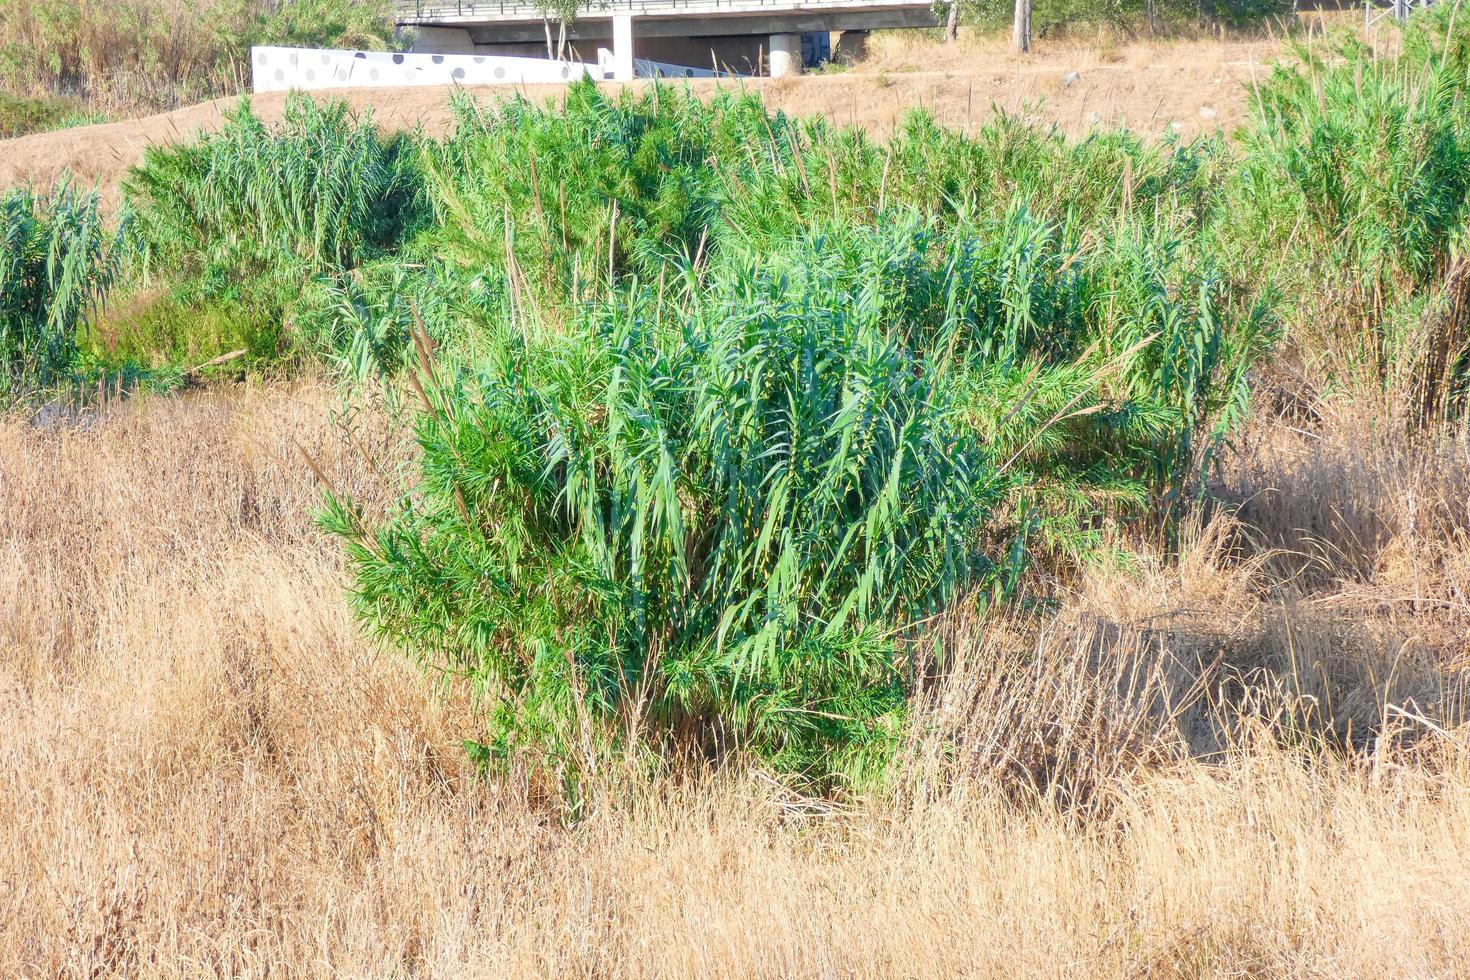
[{"left": 711, "top": 110, "right": 1229, "bottom": 244}]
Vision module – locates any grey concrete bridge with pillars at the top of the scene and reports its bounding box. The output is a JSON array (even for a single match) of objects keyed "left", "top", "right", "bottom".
[{"left": 394, "top": 0, "right": 936, "bottom": 78}]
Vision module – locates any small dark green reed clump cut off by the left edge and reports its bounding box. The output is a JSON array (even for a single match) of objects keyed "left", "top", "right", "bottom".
[{"left": 0, "top": 185, "right": 118, "bottom": 407}]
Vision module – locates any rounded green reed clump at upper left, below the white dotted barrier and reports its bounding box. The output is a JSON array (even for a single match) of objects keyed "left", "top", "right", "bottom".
[{"left": 122, "top": 94, "right": 422, "bottom": 376}]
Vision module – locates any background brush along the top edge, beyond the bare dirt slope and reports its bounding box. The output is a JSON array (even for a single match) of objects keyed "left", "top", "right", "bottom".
[{"left": 0, "top": 0, "right": 1292, "bottom": 122}]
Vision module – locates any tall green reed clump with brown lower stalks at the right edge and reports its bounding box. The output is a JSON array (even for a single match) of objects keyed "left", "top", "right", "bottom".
[{"left": 1233, "top": 4, "right": 1470, "bottom": 419}]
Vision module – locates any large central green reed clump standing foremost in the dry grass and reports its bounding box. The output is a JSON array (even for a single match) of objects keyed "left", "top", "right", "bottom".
[{"left": 325, "top": 206, "right": 1267, "bottom": 782}]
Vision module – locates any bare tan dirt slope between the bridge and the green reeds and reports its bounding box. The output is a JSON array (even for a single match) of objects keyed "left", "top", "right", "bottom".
[{"left": 0, "top": 41, "right": 1277, "bottom": 204}]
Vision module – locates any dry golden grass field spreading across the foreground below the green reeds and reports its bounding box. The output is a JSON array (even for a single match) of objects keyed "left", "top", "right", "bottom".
[{"left": 0, "top": 383, "right": 1470, "bottom": 977}]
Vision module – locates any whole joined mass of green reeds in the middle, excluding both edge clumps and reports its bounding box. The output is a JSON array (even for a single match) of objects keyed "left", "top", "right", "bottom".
[{"left": 94, "top": 72, "right": 1274, "bottom": 785}]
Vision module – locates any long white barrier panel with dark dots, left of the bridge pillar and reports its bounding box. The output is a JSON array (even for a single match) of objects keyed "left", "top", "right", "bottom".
[{"left": 250, "top": 47, "right": 602, "bottom": 93}]
